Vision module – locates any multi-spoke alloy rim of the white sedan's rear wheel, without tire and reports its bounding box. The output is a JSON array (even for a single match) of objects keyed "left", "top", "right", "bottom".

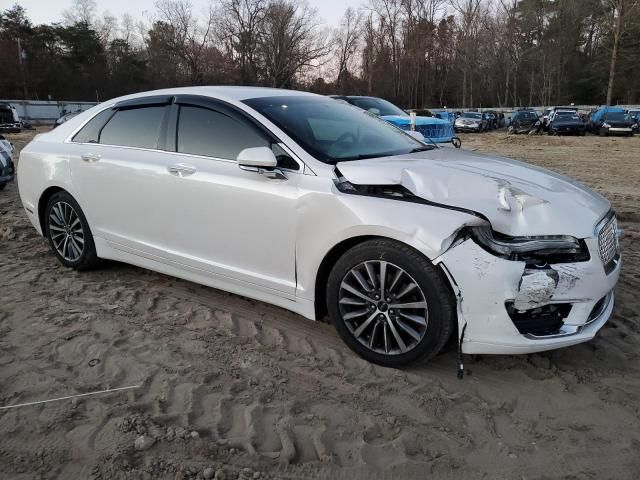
[{"left": 49, "top": 201, "right": 85, "bottom": 262}]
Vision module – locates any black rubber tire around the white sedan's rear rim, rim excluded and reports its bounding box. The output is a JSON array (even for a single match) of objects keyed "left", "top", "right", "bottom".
[{"left": 44, "top": 191, "right": 100, "bottom": 270}]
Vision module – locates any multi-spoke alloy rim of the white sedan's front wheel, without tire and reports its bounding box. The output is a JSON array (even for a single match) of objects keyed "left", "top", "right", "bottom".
[{"left": 338, "top": 260, "right": 429, "bottom": 355}]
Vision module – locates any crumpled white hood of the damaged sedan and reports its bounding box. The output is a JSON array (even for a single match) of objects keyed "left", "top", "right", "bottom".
[{"left": 337, "top": 148, "right": 610, "bottom": 238}]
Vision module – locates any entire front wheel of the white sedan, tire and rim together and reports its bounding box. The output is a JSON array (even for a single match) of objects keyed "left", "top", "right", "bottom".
[{"left": 326, "top": 239, "right": 456, "bottom": 367}]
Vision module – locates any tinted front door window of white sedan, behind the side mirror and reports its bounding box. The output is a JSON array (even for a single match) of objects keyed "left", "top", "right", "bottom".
[{"left": 178, "top": 106, "right": 269, "bottom": 160}]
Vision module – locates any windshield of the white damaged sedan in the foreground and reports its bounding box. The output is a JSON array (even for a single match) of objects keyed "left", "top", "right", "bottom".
[{"left": 244, "top": 95, "right": 434, "bottom": 163}]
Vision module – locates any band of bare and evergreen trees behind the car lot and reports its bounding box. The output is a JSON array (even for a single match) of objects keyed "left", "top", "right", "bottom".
[{"left": 0, "top": 0, "right": 640, "bottom": 108}]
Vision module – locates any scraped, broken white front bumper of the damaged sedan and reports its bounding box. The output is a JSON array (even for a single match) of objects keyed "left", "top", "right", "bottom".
[{"left": 437, "top": 237, "right": 620, "bottom": 354}]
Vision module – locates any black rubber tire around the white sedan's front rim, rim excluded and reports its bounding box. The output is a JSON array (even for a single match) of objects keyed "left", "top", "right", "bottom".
[{"left": 326, "top": 239, "right": 456, "bottom": 367}]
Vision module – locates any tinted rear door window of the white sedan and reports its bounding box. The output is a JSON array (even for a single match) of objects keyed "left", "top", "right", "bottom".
[{"left": 99, "top": 105, "right": 166, "bottom": 148}]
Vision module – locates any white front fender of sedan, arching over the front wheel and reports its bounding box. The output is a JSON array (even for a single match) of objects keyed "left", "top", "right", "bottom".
[{"left": 296, "top": 176, "right": 482, "bottom": 300}]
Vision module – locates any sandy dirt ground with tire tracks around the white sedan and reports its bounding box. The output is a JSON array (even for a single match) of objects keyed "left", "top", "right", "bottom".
[{"left": 0, "top": 128, "right": 640, "bottom": 480}]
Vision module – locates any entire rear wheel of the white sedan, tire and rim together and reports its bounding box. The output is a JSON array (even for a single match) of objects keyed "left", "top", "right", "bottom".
[{"left": 44, "top": 191, "right": 100, "bottom": 270}]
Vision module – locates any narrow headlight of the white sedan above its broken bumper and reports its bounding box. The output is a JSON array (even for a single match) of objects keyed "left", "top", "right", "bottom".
[{"left": 470, "top": 226, "right": 589, "bottom": 262}]
